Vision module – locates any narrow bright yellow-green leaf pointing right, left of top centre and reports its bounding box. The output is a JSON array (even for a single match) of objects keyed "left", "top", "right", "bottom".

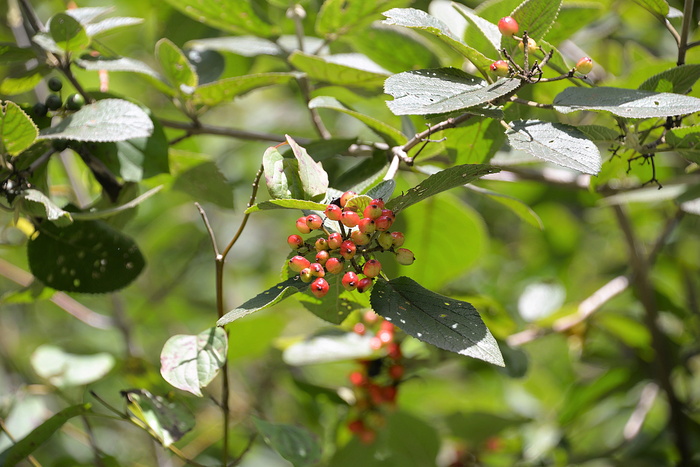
[{"left": 194, "top": 73, "right": 297, "bottom": 106}]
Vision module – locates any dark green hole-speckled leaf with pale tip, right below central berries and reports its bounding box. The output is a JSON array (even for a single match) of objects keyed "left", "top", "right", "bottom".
[{"left": 370, "top": 277, "right": 505, "bottom": 366}]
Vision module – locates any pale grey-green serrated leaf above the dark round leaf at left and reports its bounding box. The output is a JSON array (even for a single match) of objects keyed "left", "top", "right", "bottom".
[{"left": 39, "top": 99, "right": 153, "bottom": 142}]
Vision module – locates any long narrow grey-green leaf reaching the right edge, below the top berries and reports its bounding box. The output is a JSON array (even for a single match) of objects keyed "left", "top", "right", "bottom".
[{"left": 554, "top": 87, "right": 700, "bottom": 118}]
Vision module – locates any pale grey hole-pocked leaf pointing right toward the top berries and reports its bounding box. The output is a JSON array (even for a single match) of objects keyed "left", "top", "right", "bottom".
[{"left": 384, "top": 68, "right": 520, "bottom": 115}]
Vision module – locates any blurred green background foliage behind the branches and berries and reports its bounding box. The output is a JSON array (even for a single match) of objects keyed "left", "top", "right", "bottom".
[{"left": 0, "top": 0, "right": 700, "bottom": 467}]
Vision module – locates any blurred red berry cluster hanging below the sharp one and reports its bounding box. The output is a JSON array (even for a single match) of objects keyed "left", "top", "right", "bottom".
[{"left": 348, "top": 310, "right": 405, "bottom": 444}]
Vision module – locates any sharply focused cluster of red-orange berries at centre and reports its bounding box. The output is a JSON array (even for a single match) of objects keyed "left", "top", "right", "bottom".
[{"left": 287, "top": 191, "right": 415, "bottom": 298}]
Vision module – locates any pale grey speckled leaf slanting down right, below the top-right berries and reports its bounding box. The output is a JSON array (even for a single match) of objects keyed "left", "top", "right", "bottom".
[{"left": 506, "top": 120, "right": 602, "bottom": 175}]
